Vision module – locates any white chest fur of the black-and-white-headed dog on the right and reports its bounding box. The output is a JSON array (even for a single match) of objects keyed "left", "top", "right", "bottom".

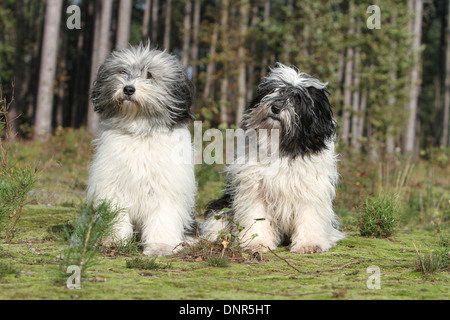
[{"left": 230, "top": 144, "right": 338, "bottom": 233}]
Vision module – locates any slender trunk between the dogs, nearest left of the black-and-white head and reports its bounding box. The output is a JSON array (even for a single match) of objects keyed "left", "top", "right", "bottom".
[{"left": 236, "top": 0, "right": 248, "bottom": 126}]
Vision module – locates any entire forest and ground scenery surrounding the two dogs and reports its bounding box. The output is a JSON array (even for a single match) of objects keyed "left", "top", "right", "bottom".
[{"left": 0, "top": 0, "right": 450, "bottom": 300}]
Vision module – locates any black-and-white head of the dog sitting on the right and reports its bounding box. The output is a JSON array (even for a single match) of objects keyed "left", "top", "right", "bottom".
[{"left": 242, "top": 63, "right": 336, "bottom": 158}]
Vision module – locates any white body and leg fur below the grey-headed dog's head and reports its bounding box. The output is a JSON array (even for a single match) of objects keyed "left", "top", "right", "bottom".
[{"left": 87, "top": 124, "right": 195, "bottom": 256}]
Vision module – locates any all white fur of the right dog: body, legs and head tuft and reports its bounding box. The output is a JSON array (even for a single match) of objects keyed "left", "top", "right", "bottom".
[{"left": 202, "top": 64, "right": 344, "bottom": 253}]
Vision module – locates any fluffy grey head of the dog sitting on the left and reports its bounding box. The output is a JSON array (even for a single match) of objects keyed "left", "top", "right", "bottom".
[{"left": 91, "top": 45, "right": 195, "bottom": 127}]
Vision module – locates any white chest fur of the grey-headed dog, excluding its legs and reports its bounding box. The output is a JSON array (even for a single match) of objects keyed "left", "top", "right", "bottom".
[{"left": 88, "top": 125, "right": 195, "bottom": 220}]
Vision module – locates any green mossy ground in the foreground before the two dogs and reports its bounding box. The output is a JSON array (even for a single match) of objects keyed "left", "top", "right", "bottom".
[{"left": 0, "top": 205, "right": 450, "bottom": 300}]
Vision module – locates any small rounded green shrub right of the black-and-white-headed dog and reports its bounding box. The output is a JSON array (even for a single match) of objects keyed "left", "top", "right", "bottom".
[{"left": 358, "top": 195, "right": 398, "bottom": 238}]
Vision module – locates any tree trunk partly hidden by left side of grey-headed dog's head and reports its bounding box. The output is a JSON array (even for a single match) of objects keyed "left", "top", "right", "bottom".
[{"left": 87, "top": 0, "right": 113, "bottom": 134}]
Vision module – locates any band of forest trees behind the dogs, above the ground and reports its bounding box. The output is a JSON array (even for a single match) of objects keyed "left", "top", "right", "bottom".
[{"left": 0, "top": 0, "right": 450, "bottom": 160}]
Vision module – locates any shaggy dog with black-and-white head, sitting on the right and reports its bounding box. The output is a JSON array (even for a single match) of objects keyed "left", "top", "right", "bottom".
[{"left": 201, "top": 63, "right": 344, "bottom": 253}]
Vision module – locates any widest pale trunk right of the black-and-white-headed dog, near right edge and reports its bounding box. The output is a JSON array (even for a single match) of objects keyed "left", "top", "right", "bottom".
[{"left": 404, "top": 0, "right": 423, "bottom": 157}]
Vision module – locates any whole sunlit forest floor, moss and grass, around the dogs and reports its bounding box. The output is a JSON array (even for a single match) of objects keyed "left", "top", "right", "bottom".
[{"left": 0, "top": 129, "right": 450, "bottom": 300}]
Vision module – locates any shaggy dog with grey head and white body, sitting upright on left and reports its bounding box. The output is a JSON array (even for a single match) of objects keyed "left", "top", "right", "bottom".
[{"left": 87, "top": 45, "right": 196, "bottom": 256}]
